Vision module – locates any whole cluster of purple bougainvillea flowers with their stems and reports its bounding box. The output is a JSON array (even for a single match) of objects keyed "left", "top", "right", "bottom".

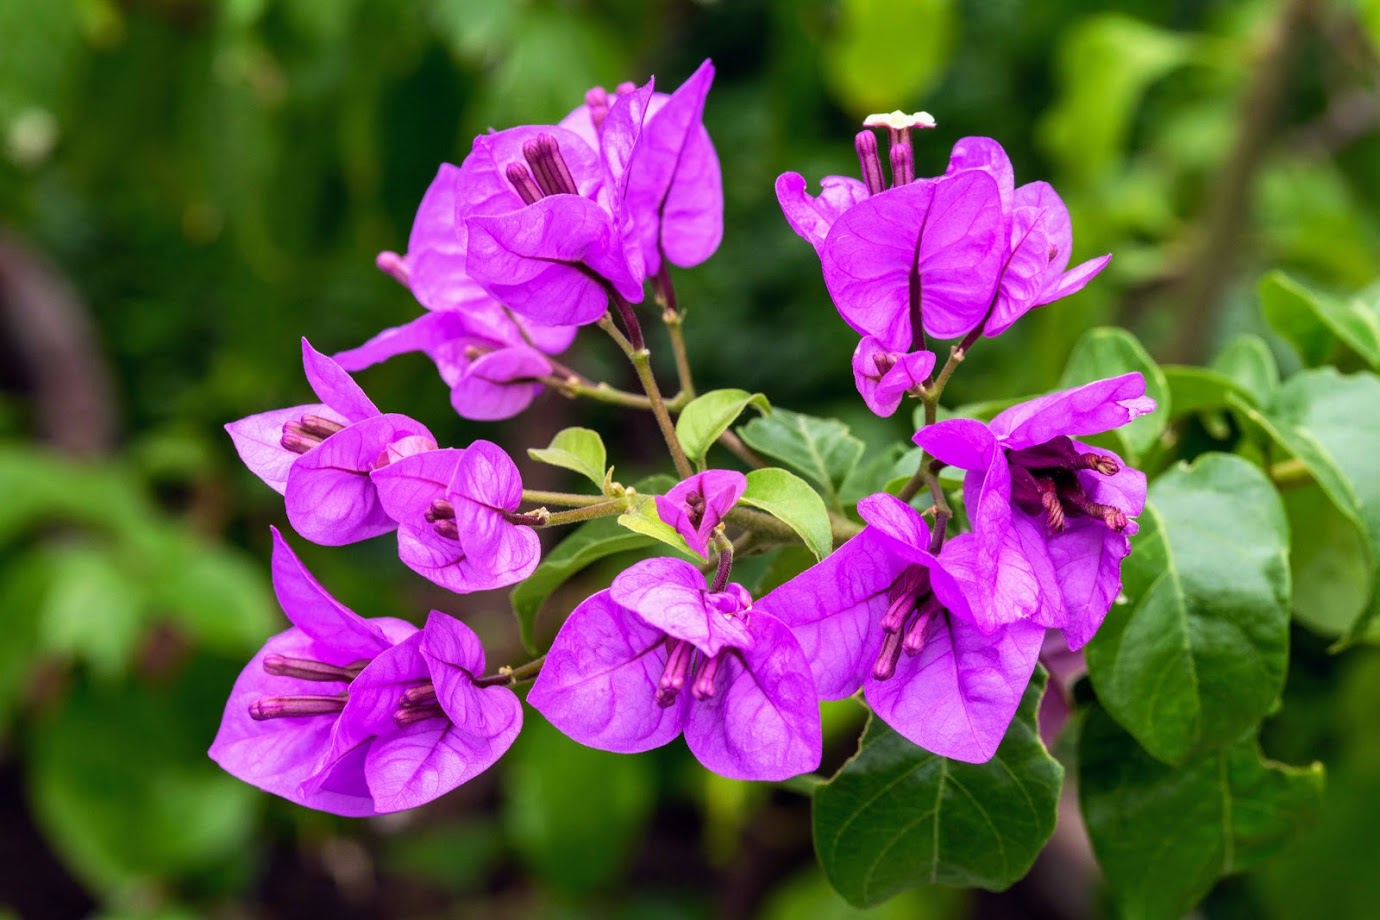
[{"left": 211, "top": 62, "right": 1155, "bottom": 815}]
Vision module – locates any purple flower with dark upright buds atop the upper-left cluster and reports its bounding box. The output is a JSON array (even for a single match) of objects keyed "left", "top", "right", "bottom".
[{"left": 455, "top": 81, "right": 651, "bottom": 326}]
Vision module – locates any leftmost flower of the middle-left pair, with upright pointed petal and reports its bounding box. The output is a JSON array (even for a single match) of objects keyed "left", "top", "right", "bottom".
[{"left": 225, "top": 338, "right": 436, "bottom": 546}]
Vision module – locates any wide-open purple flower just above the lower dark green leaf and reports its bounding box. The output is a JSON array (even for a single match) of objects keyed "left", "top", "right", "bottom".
[{"left": 758, "top": 495, "right": 1045, "bottom": 763}]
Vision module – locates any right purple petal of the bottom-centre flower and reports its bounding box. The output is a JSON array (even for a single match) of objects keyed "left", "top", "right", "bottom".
[{"left": 684, "top": 610, "right": 821, "bottom": 781}]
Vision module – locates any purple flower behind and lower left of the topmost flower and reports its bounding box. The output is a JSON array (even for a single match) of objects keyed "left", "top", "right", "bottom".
[{"left": 335, "top": 164, "right": 577, "bottom": 421}]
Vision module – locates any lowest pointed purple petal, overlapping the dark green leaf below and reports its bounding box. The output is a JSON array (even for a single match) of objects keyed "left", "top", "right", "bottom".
[{"left": 864, "top": 615, "right": 1045, "bottom": 763}]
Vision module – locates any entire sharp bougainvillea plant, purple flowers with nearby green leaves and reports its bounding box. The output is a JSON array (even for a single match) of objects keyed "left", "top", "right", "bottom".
[{"left": 211, "top": 62, "right": 1318, "bottom": 916}]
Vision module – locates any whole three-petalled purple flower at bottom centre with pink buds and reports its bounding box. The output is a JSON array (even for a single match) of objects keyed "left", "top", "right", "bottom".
[{"left": 527, "top": 559, "right": 821, "bottom": 779}]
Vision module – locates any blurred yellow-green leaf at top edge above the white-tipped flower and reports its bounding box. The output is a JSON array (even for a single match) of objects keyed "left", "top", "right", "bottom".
[{"left": 824, "top": 0, "right": 958, "bottom": 116}]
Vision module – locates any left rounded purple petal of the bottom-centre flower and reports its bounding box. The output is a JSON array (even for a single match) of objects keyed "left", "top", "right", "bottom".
[{"left": 527, "top": 590, "right": 690, "bottom": 753}]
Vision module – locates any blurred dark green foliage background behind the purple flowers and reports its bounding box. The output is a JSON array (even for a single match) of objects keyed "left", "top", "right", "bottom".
[{"left": 0, "top": 0, "right": 1380, "bottom": 919}]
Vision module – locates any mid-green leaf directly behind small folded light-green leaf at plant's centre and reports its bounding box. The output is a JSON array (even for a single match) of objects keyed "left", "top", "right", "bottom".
[{"left": 738, "top": 408, "right": 865, "bottom": 509}]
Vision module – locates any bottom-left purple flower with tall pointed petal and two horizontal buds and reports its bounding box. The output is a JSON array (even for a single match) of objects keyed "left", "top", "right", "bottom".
[{"left": 210, "top": 530, "right": 417, "bottom": 815}]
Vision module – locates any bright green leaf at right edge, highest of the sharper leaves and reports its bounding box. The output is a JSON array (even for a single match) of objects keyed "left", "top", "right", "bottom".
[{"left": 1260, "top": 270, "right": 1380, "bottom": 370}]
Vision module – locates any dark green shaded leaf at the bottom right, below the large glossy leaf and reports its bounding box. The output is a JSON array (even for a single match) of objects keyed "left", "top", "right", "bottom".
[{"left": 1078, "top": 708, "right": 1323, "bottom": 920}]
